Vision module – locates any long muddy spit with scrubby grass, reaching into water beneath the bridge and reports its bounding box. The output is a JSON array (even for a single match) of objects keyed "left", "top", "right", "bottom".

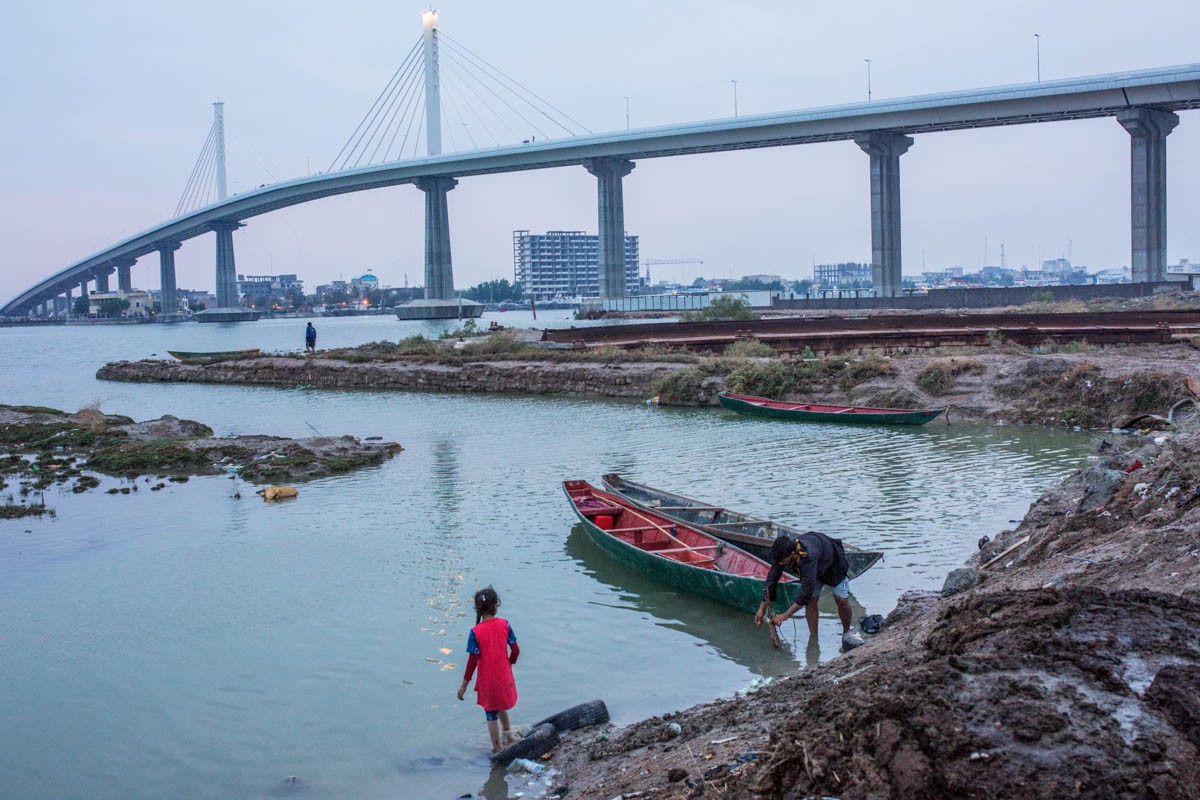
[{"left": 97, "top": 339, "right": 1196, "bottom": 428}]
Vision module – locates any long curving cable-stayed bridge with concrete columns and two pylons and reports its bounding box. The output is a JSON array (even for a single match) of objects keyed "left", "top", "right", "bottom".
[{"left": 0, "top": 12, "right": 1200, "bottom": 320}]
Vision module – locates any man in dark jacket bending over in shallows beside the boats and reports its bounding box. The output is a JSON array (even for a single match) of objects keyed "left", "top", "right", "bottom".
[{"left": 754, "top": 530, "right": 851, "bottom": 636}]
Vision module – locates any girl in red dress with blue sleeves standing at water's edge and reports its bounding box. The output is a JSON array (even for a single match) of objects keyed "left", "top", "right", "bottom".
[{"left": 458, "top": 587, "right": 521, "bottom": 753}]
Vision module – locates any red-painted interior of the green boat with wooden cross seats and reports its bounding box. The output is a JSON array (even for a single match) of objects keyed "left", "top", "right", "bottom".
[{"left": 563, "top": 481, "right": 793, "bottom": 582}]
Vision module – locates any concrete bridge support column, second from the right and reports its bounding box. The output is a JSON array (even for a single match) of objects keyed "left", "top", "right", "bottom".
[{"left": 854, "top": 132, "right": 912, "bottom": 297}]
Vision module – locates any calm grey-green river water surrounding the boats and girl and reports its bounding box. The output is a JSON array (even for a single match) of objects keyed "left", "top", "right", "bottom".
[{"left": 0, "top": 312, "right": 1092, "bottom": 800}]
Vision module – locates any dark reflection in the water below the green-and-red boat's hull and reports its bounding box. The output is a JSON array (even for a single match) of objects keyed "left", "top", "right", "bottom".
[{"left": 565, "top": 524, "right": 865, "bottom": 676}]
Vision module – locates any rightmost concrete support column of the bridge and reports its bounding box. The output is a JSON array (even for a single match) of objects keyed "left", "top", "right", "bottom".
[{"left": 1117, "top": 108, "right": 1180, "bottom": 283}]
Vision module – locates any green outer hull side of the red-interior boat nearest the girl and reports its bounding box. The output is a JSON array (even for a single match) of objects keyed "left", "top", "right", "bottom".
[{"left": 563, "top": 485, "right": 802, "bottom": 614}]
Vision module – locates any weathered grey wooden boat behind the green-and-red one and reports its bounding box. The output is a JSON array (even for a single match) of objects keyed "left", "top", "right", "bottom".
[{"left": 604, "top": 473, "right": 883, "bottom": 581}]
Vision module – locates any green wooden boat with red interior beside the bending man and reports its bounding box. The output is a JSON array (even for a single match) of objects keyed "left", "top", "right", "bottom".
[{"left": 563, "top": 481, "right": 800, "bottom": 614}]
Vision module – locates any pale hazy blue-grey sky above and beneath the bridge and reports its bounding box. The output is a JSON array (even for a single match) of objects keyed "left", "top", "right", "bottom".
[{"left": 0, "top": 0, "right": 1200, "bottom": 299}]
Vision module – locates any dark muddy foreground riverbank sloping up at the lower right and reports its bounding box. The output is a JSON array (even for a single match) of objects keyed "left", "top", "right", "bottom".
[{"left": 544, "top": 429, "right": 1200, "bottom": 799}]
